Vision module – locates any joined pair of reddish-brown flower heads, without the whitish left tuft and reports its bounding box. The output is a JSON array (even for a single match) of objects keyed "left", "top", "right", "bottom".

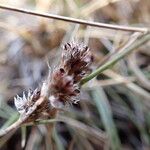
[{"left": 50, "top": 42, "right": 92, "bottom": 105}]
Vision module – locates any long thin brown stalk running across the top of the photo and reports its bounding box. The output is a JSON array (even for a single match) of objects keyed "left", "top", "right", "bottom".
[{"left": 0, "top": 5, "right": 149, "bottom": 33}]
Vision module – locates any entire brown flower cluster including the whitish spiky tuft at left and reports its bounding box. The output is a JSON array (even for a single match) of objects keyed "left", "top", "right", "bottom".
[{"left": 14, "top": 42, "right": 92, "bottom": 119}]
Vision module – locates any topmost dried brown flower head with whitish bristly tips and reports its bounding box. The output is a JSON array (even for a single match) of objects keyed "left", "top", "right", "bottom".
[{"left": 60, "top": 42, "right": 93, "bottom": 83}]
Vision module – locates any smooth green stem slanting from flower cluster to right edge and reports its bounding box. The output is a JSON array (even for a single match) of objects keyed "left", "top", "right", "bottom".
[{"left": 80, "top": 34, "right": 150, "bottom": 85}]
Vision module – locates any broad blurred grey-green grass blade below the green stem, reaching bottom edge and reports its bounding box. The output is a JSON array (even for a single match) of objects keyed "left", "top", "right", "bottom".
[{"left": 92, "top": 88, "right": 121, "bottom": 150}]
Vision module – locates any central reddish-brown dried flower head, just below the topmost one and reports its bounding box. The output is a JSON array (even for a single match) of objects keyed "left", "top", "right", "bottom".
[{"left": 50, "top": 68, "right": 80, "bottom": 104}]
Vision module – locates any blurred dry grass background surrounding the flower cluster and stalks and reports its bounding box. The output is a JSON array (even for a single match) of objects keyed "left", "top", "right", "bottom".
[{"left": 0, "top": 0, "right": 150, "bottom": 150}]
